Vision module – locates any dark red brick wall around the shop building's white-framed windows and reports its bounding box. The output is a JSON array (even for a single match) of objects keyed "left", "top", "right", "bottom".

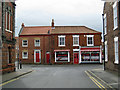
[{"left": 51, "top": 34, "right": 102, "bottom": 64}]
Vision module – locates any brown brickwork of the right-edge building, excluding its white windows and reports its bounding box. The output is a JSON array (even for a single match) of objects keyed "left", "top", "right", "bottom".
[{"left": 104, "top": 2, "right": 120, "bottom": 70}]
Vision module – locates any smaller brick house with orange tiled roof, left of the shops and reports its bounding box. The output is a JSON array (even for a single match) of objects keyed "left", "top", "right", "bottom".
[{"left": 19, "top": 24, "right": 51, "bottom": 64}]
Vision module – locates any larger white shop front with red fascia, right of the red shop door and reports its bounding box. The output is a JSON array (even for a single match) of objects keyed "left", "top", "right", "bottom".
[{"left": 80, "top": 47, "right": 102, "bottom": 63}]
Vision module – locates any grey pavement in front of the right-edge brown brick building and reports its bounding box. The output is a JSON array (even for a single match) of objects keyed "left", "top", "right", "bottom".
[{"left": 87, "top": 68, "right": 120, "bottom": 90}]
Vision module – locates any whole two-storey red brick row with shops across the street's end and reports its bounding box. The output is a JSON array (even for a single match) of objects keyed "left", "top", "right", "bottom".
[{"left": 19, "top": 20, "right": 102, "bottom": 64}]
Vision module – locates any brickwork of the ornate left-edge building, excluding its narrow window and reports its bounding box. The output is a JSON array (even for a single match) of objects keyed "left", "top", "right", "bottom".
[{"left": 1, "top": 2, "right": 15, "bottom": 73}]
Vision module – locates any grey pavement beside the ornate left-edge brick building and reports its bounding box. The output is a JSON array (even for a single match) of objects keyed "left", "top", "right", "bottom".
[{"left": 0, "top": 65, "right": 33, "bottom": 83}]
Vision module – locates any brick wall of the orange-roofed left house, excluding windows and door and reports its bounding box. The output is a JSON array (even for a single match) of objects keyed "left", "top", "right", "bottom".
[{"left": 19, "top": 36, "right": 50, "bottom": 64}]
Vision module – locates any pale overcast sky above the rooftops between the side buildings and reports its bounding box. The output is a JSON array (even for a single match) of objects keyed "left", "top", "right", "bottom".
[{"left": 15, "top": 0, "right": 104, "bottom": 36}]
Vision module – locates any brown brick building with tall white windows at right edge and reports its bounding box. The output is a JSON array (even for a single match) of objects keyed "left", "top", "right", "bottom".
[{"left": 103, "top": 2, "right": 120, "bottom": 71}]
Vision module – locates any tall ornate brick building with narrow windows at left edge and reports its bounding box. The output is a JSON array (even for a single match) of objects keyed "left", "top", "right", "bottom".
[{"left": 0, "top": 1, "right": 16, "bottom": 73}]
